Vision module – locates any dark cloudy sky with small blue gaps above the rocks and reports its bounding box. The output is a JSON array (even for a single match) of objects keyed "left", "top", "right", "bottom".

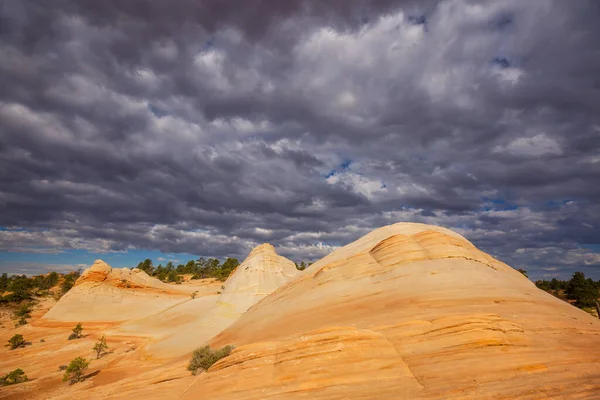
[{"left": 0, "top": 0, "right": 600, "bottom": 279}]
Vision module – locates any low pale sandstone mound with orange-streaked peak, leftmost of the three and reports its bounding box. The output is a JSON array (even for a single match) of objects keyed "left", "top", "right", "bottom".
[{"left": 40, "top": 260, "right": 195, "bottom": 325}]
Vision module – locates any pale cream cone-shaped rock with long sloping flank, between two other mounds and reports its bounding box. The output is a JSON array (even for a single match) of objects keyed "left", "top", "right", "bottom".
[{"left": 146, "top": 243, "right": 299, "bottom": 358}]
